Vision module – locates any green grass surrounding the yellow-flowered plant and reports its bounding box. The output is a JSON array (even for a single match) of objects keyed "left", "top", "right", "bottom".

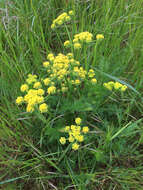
[{"left": 0, "top": 0, "right": 143, "bottom": 190}]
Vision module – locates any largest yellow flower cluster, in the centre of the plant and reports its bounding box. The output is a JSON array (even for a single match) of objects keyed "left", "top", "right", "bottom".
[{"left": 43, "top": 53, "right": 97, "bottom": 94}]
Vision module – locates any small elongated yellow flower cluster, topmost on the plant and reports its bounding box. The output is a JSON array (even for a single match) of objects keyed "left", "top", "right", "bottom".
[{"left": 51, "top": 10, "right": 74, "bottom": 29}]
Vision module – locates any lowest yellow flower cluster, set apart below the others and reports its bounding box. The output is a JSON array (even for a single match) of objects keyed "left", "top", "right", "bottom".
[{"left": 59, "top": 117, "right": 89, "bottom": 150}]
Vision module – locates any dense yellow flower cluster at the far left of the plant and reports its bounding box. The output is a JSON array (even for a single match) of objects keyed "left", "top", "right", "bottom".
[{"left": 16, "top": 74, "right": 56, "bottom": 113}]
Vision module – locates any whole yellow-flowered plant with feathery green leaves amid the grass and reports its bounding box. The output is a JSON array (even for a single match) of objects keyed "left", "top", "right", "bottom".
[{"left": 16, "top": 10, "right": 127, "bottom": 150}]
